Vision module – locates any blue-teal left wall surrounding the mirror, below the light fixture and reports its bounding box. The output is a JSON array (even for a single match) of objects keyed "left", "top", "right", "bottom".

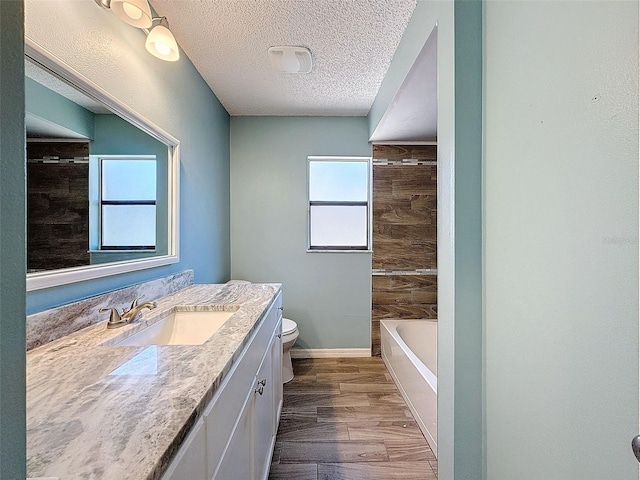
[{"left": 25, "top": 0, "right": 230, "bottom": 313}]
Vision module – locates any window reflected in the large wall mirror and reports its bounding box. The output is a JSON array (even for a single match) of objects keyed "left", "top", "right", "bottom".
[{"left": 100, "top": 157, "right": 156, "bottom": 250}]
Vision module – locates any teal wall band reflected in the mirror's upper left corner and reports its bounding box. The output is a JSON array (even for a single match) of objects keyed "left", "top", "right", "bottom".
[{"left": 24, "top": 77, "right": 94, "bottom": 138}]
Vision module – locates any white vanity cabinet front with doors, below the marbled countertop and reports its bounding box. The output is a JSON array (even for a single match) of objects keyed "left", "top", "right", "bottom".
[{"left": 162, "top": 293, "right": 282, "bottom": 480}]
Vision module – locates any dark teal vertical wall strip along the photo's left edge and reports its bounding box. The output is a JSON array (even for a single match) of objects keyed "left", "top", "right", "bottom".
[{"left": 0, "top": 0, "right": 26, "bottom": 479}]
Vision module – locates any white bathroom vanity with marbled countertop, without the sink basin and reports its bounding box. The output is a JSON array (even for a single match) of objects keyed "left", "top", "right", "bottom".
[{"left": 27, "top": 284, "right": 282, "bottom": 480}]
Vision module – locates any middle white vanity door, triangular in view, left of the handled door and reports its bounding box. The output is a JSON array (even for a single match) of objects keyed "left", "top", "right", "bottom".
[{"left": 212, "top": 390, "right": 253, "bottom": 480}]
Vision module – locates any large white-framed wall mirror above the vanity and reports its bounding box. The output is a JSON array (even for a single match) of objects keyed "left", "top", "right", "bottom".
[{"left": 25, "top": 38, "right": 179, "bottom": 290}]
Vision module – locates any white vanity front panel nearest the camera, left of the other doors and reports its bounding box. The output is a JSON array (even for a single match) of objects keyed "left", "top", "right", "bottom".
[{"left": 162, "top": 419, "right": 207, "bottom": 480}]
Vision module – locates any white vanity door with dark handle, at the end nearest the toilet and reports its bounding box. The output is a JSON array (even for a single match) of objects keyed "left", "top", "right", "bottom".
[{"left": 253, "top": 331, "right": 280, "bottom": 480}]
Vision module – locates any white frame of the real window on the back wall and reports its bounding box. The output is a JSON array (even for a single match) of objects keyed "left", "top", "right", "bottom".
[{"left": 307, "top": 155, "right": 373, "bottom": 253}]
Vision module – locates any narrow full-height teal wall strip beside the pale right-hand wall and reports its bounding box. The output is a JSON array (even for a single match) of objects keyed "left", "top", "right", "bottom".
[{"left": 453, "top": 0, "right": 484, "bottom": 480}]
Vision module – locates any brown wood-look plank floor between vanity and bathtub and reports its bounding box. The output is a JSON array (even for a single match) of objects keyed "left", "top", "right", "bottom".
[{"left": 269, "top": 357, "right": 438, "bottom": 480}]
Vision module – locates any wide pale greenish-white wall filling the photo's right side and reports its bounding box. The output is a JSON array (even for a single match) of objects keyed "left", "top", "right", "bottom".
[{"left": 484, "top": 1, "right": 638, "bottom": 480}]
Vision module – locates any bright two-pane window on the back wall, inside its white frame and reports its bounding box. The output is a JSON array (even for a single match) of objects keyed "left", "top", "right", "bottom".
[{"left": 308, "top": 157, "right": 370, "bottom": 250}]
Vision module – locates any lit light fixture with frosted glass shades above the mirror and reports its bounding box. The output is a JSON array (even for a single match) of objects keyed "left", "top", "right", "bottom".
[{"left": 94, "top": 0, "right": 180, "bottom": 62}]
